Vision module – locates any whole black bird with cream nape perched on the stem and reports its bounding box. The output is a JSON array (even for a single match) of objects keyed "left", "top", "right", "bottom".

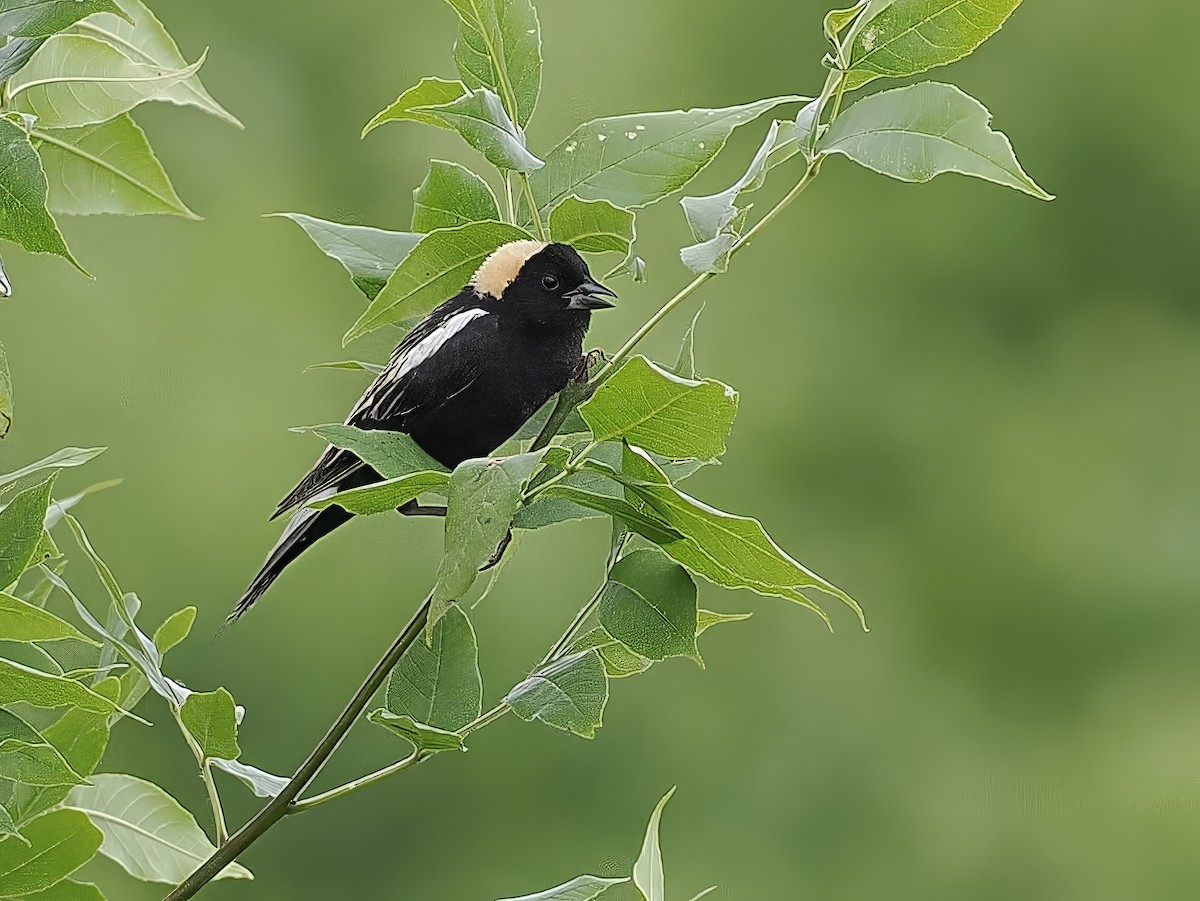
[{"left": 229, "top": 241, "right": 617, "bottom": 620}]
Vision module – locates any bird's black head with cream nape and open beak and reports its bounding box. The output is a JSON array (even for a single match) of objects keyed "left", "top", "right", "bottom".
[{"left": 470, "top": 241, "right": 617, "bottom": 323}]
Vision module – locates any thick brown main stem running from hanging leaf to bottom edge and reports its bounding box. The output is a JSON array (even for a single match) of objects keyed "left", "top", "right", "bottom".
[{"left": 166, "top": 595, "right": 432, "bottom": 901}]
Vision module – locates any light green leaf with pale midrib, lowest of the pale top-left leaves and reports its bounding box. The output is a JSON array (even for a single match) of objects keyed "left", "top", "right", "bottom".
[{"left": 32, "top": 115, "right": 199, "bottom": 220}]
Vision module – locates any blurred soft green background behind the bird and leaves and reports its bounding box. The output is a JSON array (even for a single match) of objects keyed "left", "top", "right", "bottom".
[{"left": 0, "top": 0, "right": 1200, "bottom": 901}]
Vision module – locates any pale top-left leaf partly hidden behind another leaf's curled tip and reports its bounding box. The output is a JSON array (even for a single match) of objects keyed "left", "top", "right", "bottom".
[{"left": 72, "top": 0, "right": 244, "bottom": 128}]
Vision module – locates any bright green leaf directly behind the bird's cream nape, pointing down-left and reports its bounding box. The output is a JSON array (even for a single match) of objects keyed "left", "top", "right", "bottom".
[{"left": 342, "top": 222, "right": 530, "bottom": 344}]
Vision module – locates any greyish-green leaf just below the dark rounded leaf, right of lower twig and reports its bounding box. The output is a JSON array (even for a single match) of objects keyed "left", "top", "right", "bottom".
[{"left": 504, "top": 650, "right": 608, "bottom": 738}]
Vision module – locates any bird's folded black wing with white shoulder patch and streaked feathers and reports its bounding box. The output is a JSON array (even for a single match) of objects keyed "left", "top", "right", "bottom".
[{"left": 271, "top": 299, "right": 494, "bottom": 519}]
